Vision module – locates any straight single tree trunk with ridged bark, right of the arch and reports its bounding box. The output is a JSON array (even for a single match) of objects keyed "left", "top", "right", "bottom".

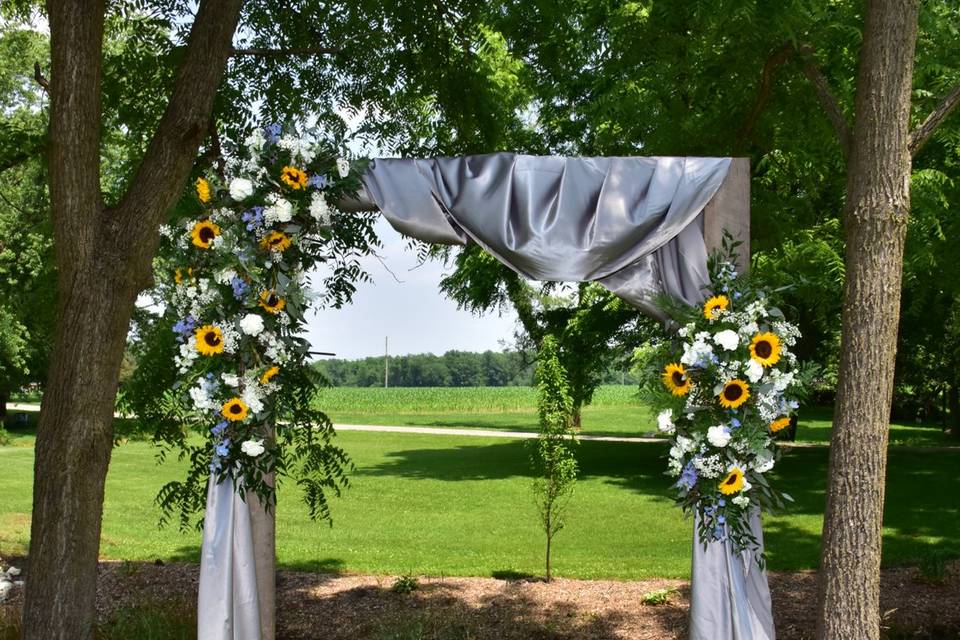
[{"left": 817, "top": 0, "right": 919, "bottom": 639}]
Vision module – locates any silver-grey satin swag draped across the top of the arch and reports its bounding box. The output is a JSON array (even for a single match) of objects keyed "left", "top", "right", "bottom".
[{"left": 364, "top": 153, "right": 730, "bottom": 315}]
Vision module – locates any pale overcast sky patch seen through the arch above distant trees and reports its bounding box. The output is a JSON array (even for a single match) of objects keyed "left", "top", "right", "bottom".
[{"left": 308, "top": 218, "right": 516, "bottom": 358}]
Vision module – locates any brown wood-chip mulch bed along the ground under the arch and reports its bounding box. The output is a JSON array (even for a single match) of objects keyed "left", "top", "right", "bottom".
[{"left": 0, "top": 558, "right": 960, "bottom": 640}]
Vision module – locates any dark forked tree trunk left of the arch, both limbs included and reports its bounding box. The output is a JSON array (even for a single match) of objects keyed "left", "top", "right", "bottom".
[{"left": 22, "top": 0, "right": 242, "bottom": 640}]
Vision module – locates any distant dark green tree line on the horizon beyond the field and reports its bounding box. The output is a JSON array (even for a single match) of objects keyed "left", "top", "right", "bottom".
[{"left": 316, "top": 351, "right": 635, "bottom": 387}]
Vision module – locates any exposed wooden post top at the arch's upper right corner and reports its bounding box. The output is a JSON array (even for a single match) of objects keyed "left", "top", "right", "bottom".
[{"left": 703, "top": 158, "right": 750, "bottom": 273}]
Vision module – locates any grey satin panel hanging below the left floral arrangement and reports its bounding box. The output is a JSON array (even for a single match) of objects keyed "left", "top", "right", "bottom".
[{"left": 197, "top": 475, "right": 260, "bottom": 640}]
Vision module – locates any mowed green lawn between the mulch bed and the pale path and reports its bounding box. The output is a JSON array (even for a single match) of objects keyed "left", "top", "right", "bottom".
[{"left": 0, "top": 432, "right": 960, "bottom": 579}]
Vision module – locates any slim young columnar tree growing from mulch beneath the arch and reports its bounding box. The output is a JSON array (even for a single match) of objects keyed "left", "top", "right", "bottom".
[{"left": 531, "top": 336, "right": 578, "bottom": 580}]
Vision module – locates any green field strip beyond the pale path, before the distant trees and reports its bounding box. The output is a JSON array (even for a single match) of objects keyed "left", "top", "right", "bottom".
[{"left": 317, "top": 385, "right": 960, "bottom": 446}]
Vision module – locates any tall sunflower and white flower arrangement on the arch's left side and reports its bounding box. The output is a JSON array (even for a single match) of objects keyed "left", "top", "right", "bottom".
[{"left": 148, "top": 125, "right": 376, "bottom": 518}]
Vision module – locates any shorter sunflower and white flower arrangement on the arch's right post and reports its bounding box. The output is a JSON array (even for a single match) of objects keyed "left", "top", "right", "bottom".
[{"left": 646, "top": 243, "right": 810, "bottom": 564}]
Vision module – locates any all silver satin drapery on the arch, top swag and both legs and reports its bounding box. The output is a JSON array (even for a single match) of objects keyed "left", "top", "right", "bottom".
[{"left": 198, "top": 153, "right": 774, "bottom": 640}]
